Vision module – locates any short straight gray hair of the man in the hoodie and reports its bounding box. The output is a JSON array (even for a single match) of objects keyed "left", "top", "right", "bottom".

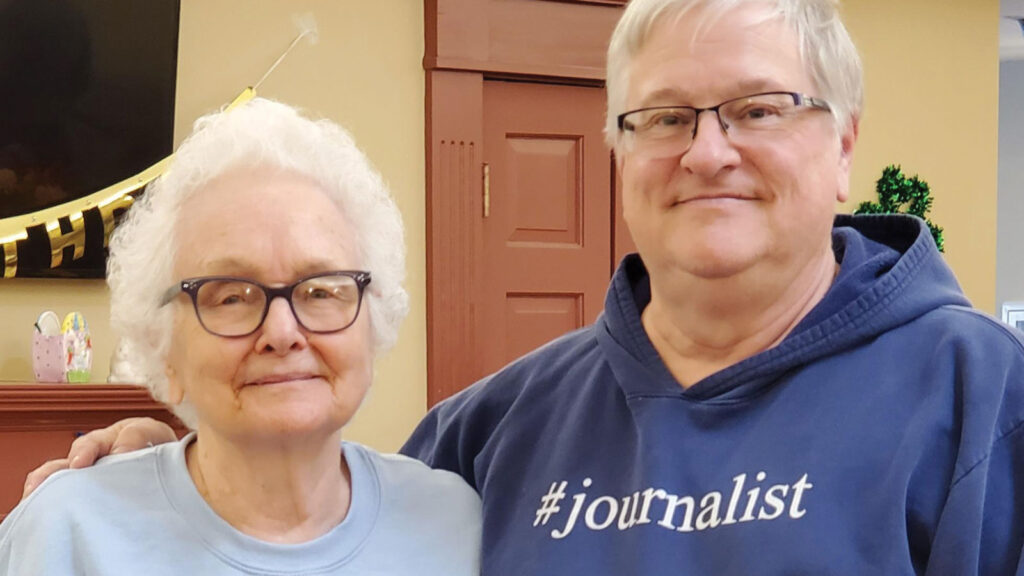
[{"left": 604, "top": 0, "right": 864, "bottom": 148}]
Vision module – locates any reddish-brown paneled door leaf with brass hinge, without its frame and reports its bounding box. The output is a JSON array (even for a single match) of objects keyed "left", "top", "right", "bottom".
[{"left": 477, "top": 81, "right": 612, "bottom": 376}]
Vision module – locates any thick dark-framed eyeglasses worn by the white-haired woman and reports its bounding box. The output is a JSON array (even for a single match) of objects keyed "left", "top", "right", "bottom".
[{"left": 160, "top": 270, "right": 370, "bottom": 338}]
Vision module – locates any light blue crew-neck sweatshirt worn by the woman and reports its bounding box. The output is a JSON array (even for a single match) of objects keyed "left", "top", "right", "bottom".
[{"left": 0, "top": 435, "right": 480, "bottom": 576}]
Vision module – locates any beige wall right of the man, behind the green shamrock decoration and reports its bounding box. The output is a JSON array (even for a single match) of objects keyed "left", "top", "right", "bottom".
[{"left": 841, "top": 0, "right": 999, "bottom": 313}]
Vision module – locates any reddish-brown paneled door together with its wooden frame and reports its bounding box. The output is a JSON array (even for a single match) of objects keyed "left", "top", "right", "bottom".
[{"left": 423, "top": 0, "right": 632, "bottom": 406}]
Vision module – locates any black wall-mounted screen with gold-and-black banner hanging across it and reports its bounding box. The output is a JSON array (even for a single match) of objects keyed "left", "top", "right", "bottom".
[{"left": 0, "top": 0, "right": 180, "bottom": 278}]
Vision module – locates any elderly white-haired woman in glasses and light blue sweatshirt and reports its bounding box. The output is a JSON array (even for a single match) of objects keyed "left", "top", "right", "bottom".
[{"left": 0, "top": 99, "right": 480, "bottom": 575}]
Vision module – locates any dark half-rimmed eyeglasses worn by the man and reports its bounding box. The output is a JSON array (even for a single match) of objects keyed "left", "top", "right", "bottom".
[{"left": 617, "top": 92, "right": 831, "bottom": 156}]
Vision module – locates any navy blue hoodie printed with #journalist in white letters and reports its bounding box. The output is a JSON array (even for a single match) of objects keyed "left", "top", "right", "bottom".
[{"left": 403, "top": 216, "right": 1024, "bottom": 576}]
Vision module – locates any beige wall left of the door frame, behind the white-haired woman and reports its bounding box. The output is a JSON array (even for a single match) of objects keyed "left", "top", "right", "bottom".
[{"left": 0, "top": 0, "right": 426, "bottom": 450}]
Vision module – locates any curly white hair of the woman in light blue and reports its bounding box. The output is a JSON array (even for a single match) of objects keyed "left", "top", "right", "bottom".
[{"left": 106, "top": 98, "right": 409, "bottom": 427}]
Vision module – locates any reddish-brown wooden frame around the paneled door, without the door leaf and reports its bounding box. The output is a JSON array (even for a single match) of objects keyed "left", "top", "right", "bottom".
[{"left": 423, "top": 0, "right": 626, "bottom": 408}]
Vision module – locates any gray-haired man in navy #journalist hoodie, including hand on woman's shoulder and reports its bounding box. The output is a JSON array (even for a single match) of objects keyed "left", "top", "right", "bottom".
[{"left": 22, "top": 0, "right": 1024, "bottom": 575}]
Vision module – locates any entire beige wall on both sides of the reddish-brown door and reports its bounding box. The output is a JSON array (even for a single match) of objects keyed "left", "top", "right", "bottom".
[{"left": 0, "top": 0, "right": 998, "bottom": 450}]
